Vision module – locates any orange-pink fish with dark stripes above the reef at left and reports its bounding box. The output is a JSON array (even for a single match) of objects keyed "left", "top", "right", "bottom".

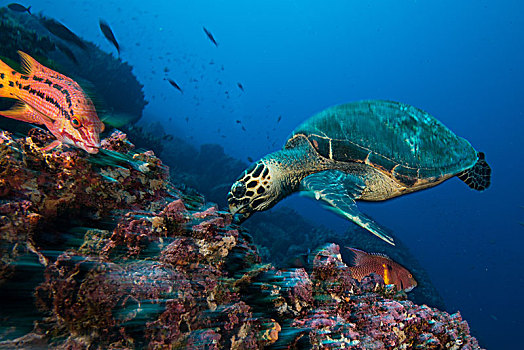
[{"left": 0, "top": 51, "right": 104, "bottom": 153}]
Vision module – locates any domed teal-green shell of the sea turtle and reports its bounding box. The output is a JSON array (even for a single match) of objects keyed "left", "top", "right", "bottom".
[{"left": 285, "top": 100, "right": 477, "bottom": 186}]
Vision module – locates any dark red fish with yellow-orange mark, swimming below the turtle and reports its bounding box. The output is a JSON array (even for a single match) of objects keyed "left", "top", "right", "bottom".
[{"left": 346, "top": 247, "right": 417, "bottom": 292}]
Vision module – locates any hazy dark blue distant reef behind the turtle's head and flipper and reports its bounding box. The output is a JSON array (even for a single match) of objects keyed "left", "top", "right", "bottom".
[{"left": 138, "top": 122, "right": 445, "bottom": 310}]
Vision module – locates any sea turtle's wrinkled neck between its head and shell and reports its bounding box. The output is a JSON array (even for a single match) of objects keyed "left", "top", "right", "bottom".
[{"left": 263, "top": 144, "right": 322, "bottom": 198}]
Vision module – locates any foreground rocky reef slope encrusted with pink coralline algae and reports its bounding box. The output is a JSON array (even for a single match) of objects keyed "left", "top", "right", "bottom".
[{"left": 0, "top": 132, "right": 479, "bottom": 349}]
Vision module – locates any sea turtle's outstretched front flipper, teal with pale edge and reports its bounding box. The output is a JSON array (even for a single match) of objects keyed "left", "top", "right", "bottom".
[{"left": 300, "top": 170, "right": 395, "bottom": 245}]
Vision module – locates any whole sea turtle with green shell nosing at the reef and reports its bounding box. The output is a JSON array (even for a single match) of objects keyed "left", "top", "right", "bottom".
[{"left": 227, "top": 100, "right": 491, "bottom": 244}]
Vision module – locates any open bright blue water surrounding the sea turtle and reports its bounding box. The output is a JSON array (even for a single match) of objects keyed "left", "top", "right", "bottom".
[{"left": 31, "top": 0, "right": 524, "bottom": 349}]
